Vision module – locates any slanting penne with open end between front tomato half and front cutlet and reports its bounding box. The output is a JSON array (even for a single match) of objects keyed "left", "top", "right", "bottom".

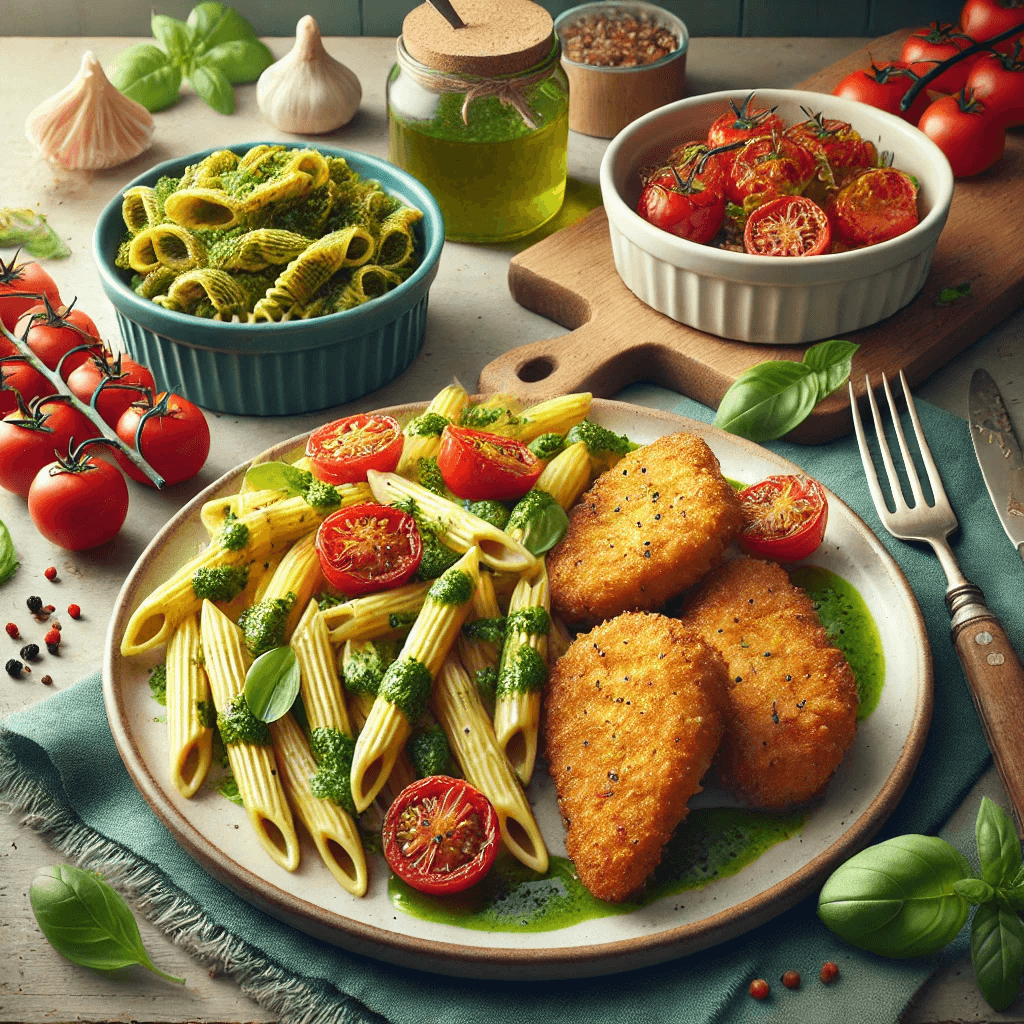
[{"left": 440, "top": 654, "right": 548, "bottom": 873}]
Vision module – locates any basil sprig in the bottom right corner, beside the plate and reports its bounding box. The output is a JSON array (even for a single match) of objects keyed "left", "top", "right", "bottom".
[{"left": 818, "top": 797, "right": 1024, "bottom": 1011}]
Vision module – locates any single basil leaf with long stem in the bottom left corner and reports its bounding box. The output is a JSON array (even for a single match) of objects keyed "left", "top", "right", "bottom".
[{"left": 29, "top": 864, "right": 184, "bottom": 985}]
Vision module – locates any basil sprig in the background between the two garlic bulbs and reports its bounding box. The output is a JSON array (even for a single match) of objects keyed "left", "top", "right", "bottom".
[{"left": 111, "top": 0, "right": 273, "bottom": 114}]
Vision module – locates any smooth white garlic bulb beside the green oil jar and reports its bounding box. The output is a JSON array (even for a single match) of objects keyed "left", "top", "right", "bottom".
[{"left": 256, "top": 14, "right": 362, "bottom": 135}]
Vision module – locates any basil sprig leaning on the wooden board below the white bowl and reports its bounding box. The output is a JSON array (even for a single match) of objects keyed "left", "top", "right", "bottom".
[{"left": 715, "top": 339, "right": 860, "bottom": 441}]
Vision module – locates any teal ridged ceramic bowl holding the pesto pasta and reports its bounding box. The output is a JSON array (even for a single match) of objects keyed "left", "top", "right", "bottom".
[{"left": 93, "top": 142, "right": 444, "bottom": 416}]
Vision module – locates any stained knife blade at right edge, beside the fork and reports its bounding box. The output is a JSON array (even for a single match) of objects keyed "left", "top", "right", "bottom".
[{"left": 968, "top": 369, "right": 1024, "bottom": 558}]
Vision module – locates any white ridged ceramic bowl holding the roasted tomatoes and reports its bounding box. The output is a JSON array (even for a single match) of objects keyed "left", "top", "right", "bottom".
[{"left": 600, "top": 89, "right": 953, "bottom": 345}]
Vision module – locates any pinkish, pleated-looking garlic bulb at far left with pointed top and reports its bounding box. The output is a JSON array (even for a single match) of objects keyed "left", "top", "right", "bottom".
[{"left": 25, "top": 50, "right": 154, "bottom": 170}]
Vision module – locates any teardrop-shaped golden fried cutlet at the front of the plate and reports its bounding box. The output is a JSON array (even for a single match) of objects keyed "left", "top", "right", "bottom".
[{"left": 543, "top": 611, "right": 727, "bottom": 902}]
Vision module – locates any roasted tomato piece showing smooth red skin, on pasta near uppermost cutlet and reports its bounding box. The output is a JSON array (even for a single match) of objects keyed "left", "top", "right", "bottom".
[{"left": 437, "top": 424, "right": 544, "bottom": 502}]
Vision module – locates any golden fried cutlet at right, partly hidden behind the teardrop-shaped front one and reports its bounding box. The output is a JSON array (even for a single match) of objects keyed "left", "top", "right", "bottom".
[{"left": 683, "top": 558, "right": 857, "bottom": 810}]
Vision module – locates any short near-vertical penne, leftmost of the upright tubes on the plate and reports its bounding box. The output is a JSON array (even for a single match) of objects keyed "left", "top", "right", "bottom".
[{"left": 166, "top": 615, "right": 215, "bottom": 797}]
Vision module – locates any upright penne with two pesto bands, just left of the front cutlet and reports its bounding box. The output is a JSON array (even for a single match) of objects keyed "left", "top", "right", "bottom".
[{"left": 495, "top": 568, "right": 551, "bottom": 785}]
